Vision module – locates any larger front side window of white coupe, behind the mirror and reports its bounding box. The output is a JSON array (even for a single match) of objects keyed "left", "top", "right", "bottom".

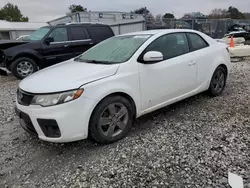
[{"left": 143, "top": 33, "right": 189, "bottom": 60}]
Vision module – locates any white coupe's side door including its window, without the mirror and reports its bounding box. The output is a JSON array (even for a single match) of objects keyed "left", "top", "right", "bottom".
[{"left": 138, "top": 33, "right": 197, "bottom": 111}]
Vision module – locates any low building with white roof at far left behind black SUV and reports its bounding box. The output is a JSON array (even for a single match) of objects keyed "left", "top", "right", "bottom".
[{"left": 0, "top": 20, "right": 48, "bottom": 39}]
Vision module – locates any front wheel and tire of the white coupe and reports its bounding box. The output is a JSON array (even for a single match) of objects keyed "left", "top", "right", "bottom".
[{"left": 89, "top": 96, "right": 134, "bottom": 144}]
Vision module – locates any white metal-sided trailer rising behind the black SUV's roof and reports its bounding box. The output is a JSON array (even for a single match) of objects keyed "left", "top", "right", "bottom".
[{"left": 47, "top": 12, "right": 146, "bottom": 35}]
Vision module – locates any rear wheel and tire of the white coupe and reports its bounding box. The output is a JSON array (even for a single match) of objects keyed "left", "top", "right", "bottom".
[{"left": 208, "top": 67, "right": 227, "bottom": 97}]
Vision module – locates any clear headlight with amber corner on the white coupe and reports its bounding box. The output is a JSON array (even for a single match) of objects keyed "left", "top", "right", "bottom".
[{"left": 31, "top": 89, "right": 83, "bottom": 107}]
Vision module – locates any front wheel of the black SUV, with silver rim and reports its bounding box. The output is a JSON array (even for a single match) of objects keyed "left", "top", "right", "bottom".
[{"left": 10, "top": 57, "right": 38, "bottom": 79}]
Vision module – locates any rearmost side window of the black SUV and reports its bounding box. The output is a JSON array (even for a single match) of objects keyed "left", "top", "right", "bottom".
[{"left": 89, "top": 26, "right": 114, "bottom": 42}]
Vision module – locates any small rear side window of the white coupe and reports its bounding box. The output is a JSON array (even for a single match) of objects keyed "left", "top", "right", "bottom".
[{"left": 187, "top": 33, "right": 208, "bottom": 51}]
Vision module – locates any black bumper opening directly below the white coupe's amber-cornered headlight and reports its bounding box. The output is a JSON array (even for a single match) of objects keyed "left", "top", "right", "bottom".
[{"left": 37, "top": 119, "right": 61, "bottom": 138}]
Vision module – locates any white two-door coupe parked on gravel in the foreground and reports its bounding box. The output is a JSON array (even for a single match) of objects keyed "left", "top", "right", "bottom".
[{"left": 16, "top": 29, "right": 230, "bottom": 144}]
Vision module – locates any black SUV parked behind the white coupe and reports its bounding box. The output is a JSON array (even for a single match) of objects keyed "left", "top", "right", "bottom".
[{"left": 0, "top": 23, "right": 114, "bottom": 79}]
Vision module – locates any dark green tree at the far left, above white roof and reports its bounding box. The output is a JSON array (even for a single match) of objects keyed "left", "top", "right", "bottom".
[{"left": 0, "top": 3, "right": 29, "bottom": 22}]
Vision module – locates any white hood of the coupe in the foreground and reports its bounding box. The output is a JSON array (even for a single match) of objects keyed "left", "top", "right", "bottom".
[{"left": 19, "top": 59, "right": 119, "bottom": 94}]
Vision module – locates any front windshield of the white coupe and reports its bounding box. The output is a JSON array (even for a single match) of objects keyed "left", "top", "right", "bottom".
[{"left": 75, "top": 35, "right": 151, "bottom": 64}]
